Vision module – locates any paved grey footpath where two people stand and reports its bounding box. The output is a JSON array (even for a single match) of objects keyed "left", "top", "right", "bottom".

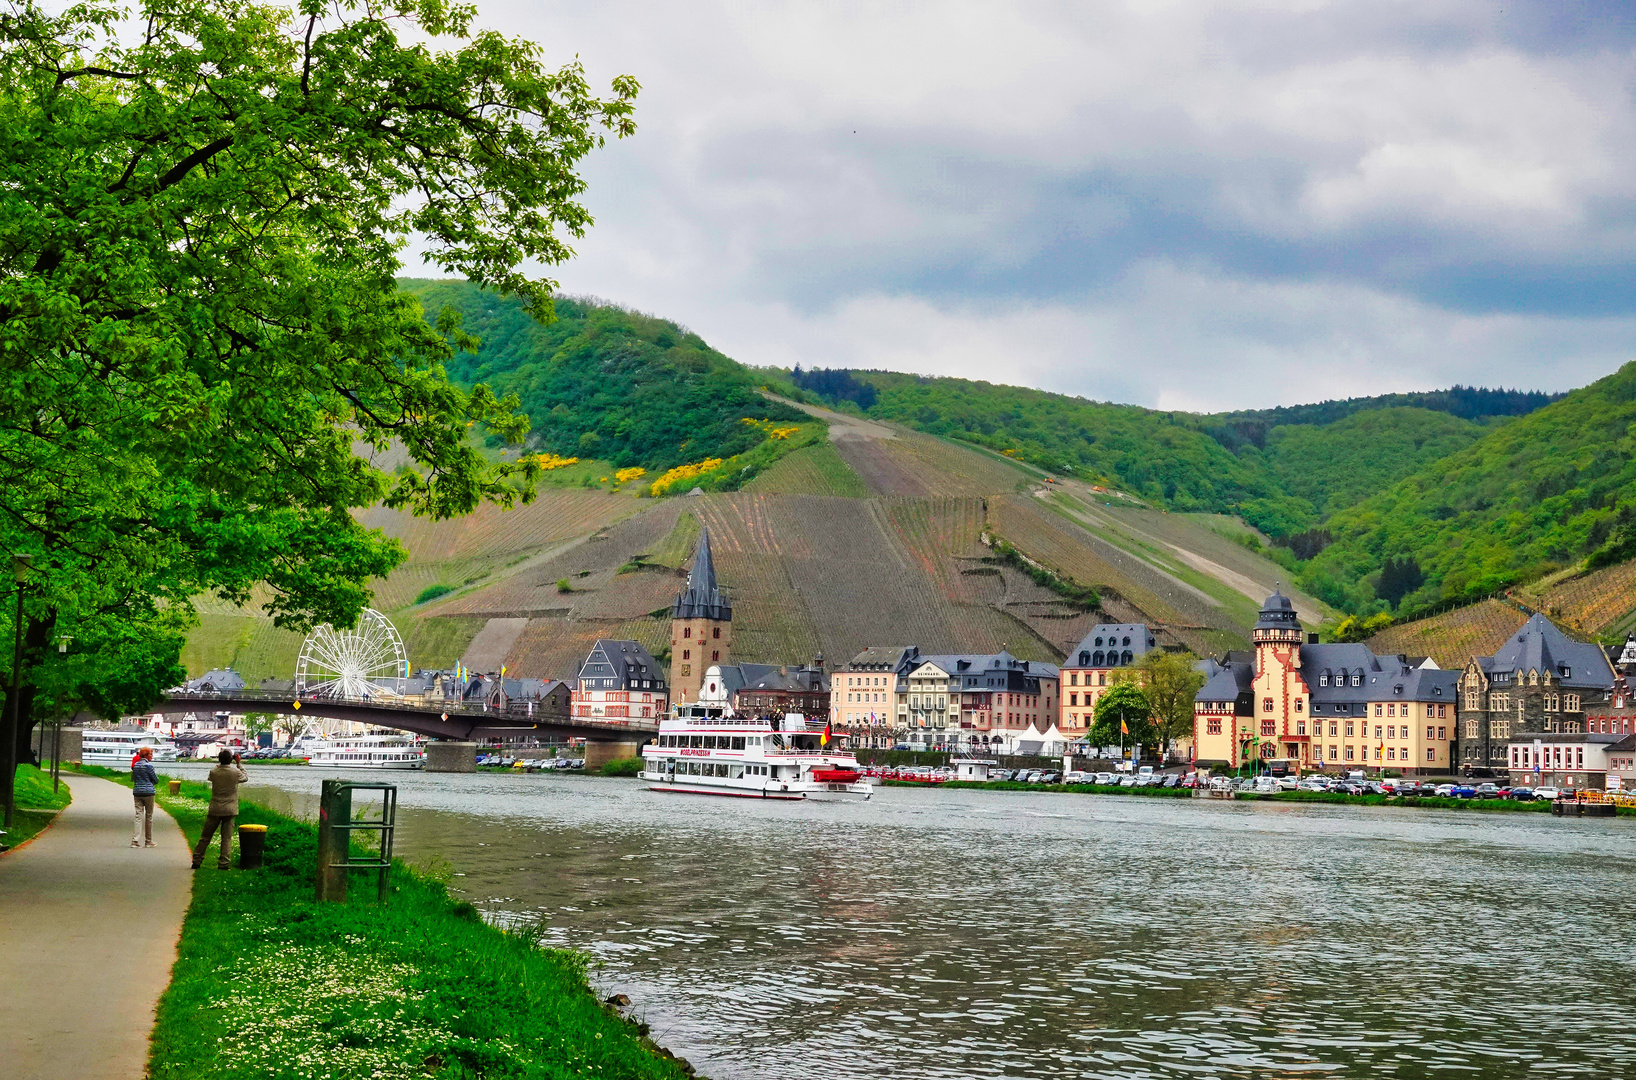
[{"left": 0, "top": 776, "right": 193, "bottom": 1080}]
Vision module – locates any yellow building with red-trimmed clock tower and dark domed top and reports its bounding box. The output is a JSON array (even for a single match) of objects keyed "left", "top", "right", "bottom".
[{"left": 1193, "top": 591, "right": 1459, "bottom": 776}]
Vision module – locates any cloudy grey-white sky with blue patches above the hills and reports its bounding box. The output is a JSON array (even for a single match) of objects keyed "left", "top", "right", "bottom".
[{"left": 431, "top": 0, "right": 1636, "bottom": 409}]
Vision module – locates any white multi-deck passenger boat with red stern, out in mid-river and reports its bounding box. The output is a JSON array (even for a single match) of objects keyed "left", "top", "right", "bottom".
[{"left": 638, "top": 704, "right": 874, "bottom": 802}]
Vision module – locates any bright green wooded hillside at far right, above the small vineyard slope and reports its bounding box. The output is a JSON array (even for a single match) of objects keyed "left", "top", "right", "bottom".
[{"left": 1302, "top": 363, "right": 1636, "bottom": 610}]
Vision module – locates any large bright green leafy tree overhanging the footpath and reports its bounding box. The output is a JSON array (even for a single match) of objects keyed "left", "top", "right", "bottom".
[{"left": 0, "top": 0, "right": 636, "bottom": 782}]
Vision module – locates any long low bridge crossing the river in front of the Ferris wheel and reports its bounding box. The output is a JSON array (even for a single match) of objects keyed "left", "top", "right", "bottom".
[{"left": 144, "top": 689, "right": 659, "bottom": 743}]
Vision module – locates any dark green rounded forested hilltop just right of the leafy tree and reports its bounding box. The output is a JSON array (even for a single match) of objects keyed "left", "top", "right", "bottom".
[{"left": 399, "top": 278, "right": 808, "bottom": 471}]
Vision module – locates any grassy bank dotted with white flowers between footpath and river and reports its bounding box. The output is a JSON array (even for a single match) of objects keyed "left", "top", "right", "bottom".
[{"left": 78, "top": 771, "right": 689, "bottom": 1080}]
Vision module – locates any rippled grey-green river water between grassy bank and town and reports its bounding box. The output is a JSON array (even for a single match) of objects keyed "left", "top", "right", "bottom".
[{"left": 167, "top": 764, "right": 1636, "bottom": 1080}]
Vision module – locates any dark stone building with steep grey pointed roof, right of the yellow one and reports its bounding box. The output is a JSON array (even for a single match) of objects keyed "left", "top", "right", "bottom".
[{"left": 1458, "top": 615, "right": 1616, "bottom": 776}]
